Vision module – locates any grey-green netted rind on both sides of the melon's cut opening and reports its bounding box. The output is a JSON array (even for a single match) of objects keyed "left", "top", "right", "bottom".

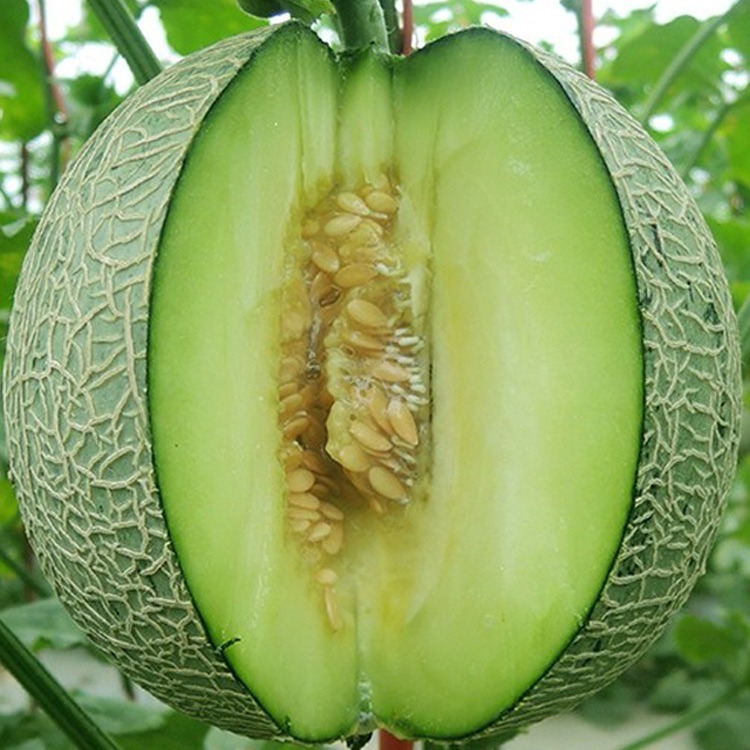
[{"left": 4, "top": 25, "right": 741, "bottom": 738}]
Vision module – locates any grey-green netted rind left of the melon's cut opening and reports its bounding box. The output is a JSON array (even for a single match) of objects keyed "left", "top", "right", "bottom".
[{"left": 5, "top": 29, "right": 278, "bottom": 736}]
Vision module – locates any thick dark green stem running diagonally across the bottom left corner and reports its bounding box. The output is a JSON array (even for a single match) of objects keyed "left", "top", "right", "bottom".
[{"left": 0, "top": 619, "right": 120, "bottom": 750}]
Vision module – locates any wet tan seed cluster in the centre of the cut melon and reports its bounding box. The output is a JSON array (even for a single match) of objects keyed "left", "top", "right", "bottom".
[{"left": 279, "top": 175, "right": 429, "bottom": 630}]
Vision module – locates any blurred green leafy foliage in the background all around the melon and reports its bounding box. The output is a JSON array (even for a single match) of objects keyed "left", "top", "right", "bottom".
[{"left": 0, "top": 0, "right": 750, "bottom": 750}]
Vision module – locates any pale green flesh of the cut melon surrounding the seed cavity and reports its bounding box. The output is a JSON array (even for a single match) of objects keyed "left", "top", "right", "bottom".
[{"left": 149, "top": 29, "right": 642, "bottom": 739}]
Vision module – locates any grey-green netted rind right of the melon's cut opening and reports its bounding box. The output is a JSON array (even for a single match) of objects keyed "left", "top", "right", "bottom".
[{"left": 484, "top": 39, "right": 741, "bottom": 734}]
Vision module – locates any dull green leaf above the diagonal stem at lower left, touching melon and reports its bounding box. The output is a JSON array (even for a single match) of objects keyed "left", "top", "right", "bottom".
[{"left": 2, "top": 598, "right": 87, "bottom": 651}]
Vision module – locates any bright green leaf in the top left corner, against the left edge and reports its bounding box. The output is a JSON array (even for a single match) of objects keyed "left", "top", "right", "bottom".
[{"left": 0, "top": 0, "right": 47, "bottom": 141}]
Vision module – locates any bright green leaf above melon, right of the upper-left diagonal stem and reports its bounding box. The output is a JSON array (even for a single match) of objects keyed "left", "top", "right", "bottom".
[{"left": 151, "top": 0, "right": 266, "bottom": 55}]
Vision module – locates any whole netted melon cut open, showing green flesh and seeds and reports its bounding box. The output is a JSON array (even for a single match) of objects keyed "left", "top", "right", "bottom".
[{"left": 4, "top": 23, "right": 740, "bottom": 742}]
